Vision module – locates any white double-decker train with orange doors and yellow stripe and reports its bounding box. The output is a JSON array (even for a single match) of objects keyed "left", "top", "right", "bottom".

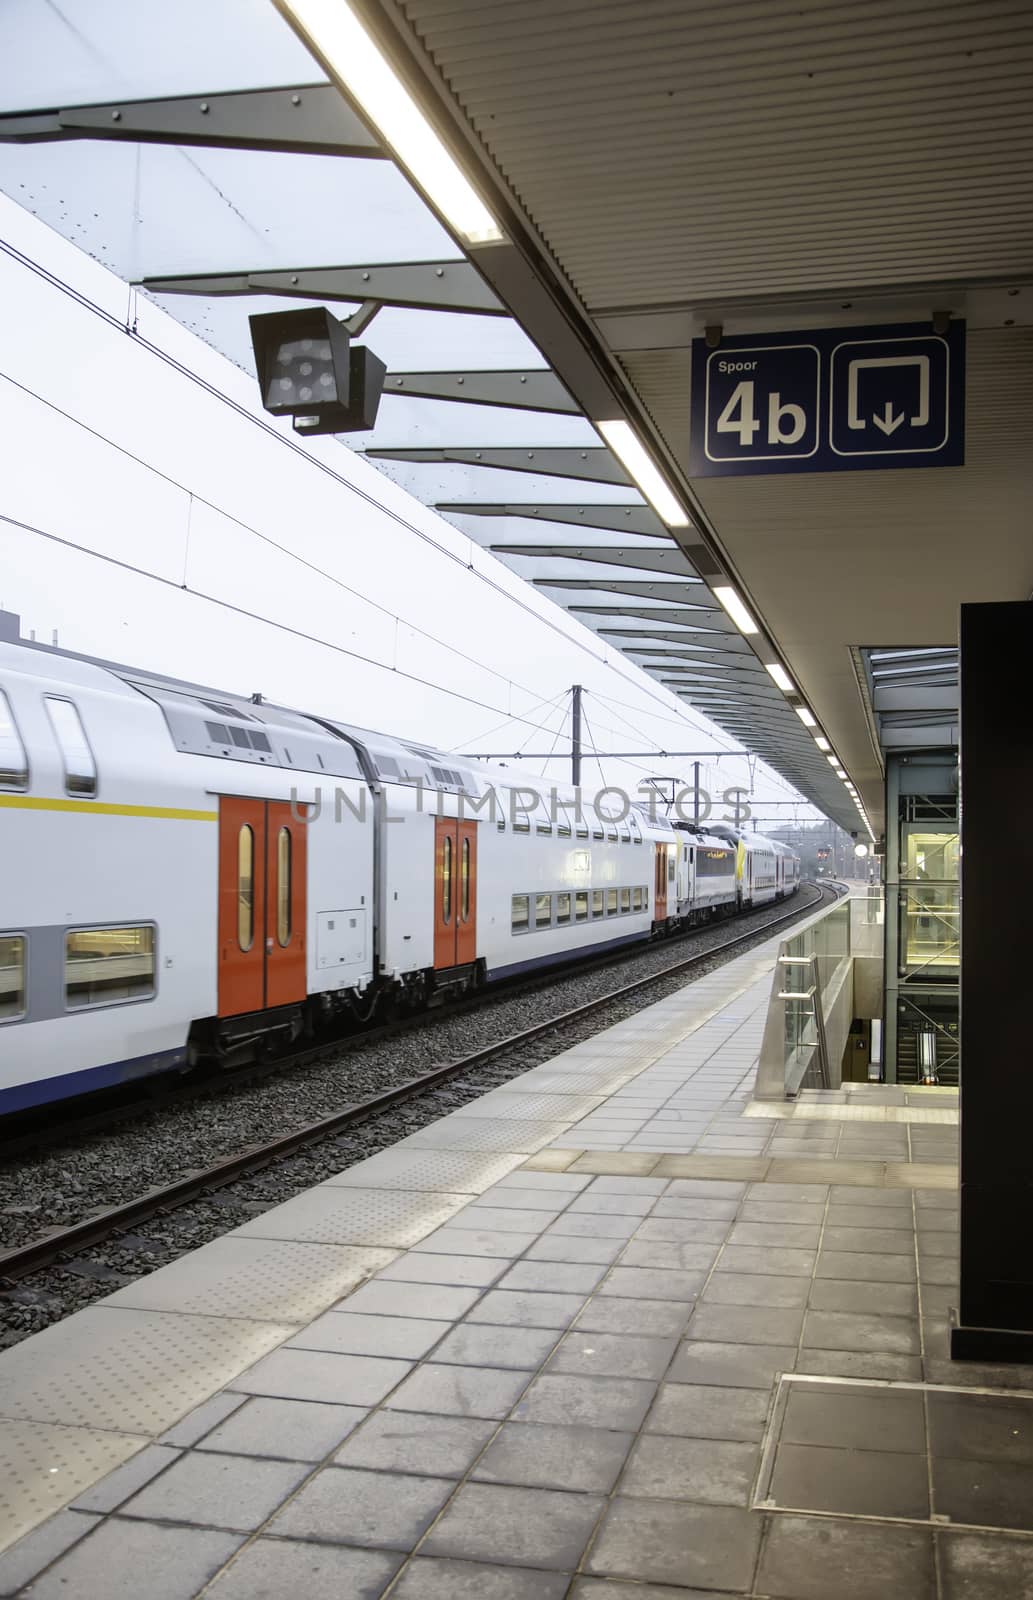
[{"left": 0, "top": 624, "right": 800, "bottom": 1115}]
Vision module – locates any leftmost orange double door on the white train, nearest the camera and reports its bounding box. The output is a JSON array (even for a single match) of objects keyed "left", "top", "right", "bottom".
[{"left": 219, "top": 795, "right": 307, "bottom": 1016}]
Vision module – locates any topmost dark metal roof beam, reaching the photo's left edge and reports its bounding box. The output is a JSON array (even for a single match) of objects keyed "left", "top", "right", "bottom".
[{"left": 0, "top": 83, "right": 384, "bottom": 158}]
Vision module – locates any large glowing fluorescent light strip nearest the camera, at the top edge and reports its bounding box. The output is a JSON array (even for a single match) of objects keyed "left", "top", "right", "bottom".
[{"left": 281, "top": 0, "right": 504, "bottom": 245}]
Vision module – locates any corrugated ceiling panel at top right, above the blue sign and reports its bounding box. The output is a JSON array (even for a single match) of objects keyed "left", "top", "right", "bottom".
[{"left": 397, "top": 0, "right": 1033, "bottom": 310}]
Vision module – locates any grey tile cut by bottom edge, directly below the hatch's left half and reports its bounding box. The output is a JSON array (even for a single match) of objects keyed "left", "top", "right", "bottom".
[{"left": 756, "top": 1517, "right": 940, "bottom": 1600}]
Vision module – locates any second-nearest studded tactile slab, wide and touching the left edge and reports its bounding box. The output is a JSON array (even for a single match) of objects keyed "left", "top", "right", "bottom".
[{"left": 0, "top": 1305, "right": 296, "bottom": 1435}]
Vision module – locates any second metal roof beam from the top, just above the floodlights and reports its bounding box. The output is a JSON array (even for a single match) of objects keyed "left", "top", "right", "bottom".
[{"left": 141, "top": 261, "right": 509, "bottom": 317}]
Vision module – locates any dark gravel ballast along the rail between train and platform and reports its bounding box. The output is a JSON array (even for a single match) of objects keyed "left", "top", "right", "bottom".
[{"left": 0, "top": 894, "right": 817, "bottom": 1347}]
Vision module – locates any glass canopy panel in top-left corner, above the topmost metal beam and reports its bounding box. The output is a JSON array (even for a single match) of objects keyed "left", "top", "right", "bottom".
[{"left": 0, "top": 0, "right": 326, "bottom": 110}]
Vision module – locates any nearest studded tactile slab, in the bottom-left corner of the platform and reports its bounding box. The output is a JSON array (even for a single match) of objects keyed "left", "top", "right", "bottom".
[{"left": 0, "top": 1421, "right": 147, "bottom": 1548}]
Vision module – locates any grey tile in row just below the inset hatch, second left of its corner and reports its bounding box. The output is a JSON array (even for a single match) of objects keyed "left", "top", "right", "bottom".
[{"left": 424, "top": 1483, "right": 606, "bottom": 1573}]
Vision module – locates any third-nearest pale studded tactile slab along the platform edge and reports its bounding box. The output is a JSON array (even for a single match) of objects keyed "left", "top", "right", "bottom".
[{"left": 107, "top": 1234, "right": 395, "bottom": 1323}]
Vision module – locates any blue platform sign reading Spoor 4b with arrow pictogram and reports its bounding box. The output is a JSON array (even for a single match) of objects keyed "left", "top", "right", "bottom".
[{"left": 689, "top": 322, "right": 964, "bottom": 477}]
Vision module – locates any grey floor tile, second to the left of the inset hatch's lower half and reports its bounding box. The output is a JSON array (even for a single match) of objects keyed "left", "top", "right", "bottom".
[{"left": 473, "top": 1422, "right": 635, "bottom": 1494}]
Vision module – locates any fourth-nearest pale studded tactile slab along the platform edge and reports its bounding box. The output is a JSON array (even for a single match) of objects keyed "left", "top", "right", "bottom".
[{"left": 237, "top": 1184, "right": 470, "bottom": 1250}]
